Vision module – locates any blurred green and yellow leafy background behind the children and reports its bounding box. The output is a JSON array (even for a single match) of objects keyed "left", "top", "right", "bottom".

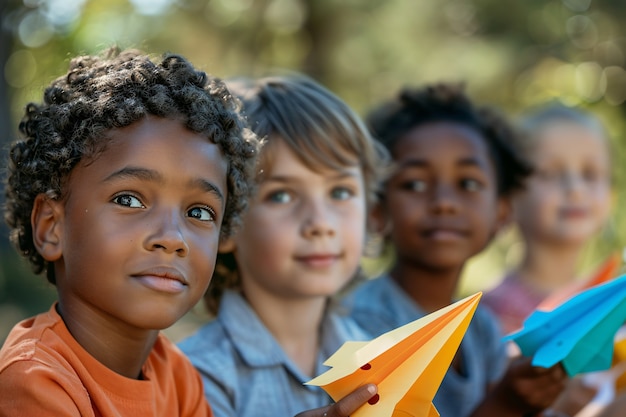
[{"left": 0, "top": 0, "right": 626, "bottom": 343}]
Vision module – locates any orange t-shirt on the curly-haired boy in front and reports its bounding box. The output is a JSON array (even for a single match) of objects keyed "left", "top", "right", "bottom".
[{"left": 0, "top": 305, "right": 213, "bottom": 417}]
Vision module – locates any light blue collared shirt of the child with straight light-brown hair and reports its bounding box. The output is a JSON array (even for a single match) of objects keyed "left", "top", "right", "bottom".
[{"left": 179, "top": 291, "right": 367, "bottom": 417}]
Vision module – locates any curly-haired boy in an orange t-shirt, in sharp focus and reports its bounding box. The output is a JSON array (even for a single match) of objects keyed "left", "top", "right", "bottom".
[{"left": 0, "top": 48, "right": 259, "bottom": 417}]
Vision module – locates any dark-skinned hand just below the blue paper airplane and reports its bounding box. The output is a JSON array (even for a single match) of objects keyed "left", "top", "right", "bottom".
[{"left": 493, "top": 357, "right": 568, "bottom": 414}]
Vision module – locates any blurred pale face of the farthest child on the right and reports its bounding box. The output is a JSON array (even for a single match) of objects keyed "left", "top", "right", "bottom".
[{"left": 513, "top": 122, "right": 611, "bottom": 244}]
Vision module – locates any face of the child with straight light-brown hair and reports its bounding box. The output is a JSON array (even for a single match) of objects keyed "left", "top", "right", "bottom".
[{"left": 233, "top": 139, "right": 366, "bottom": 299}]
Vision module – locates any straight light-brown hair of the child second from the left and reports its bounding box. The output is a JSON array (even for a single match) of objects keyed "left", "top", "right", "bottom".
[{"left": 205, "top": 74, "right": 389, "bottom": 314}]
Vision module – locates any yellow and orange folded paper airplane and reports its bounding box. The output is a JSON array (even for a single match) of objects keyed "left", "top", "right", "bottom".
[{"left": 307, "top": 292, "right": 482, "bottom": 417}]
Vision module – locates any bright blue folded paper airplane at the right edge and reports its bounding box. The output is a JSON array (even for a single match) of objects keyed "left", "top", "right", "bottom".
[{"left": 504, "top": 275, "right": 626, "bottom": 376}]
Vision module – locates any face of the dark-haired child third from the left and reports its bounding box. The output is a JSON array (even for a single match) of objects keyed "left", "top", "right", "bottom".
[{"left": 382, "top": 122, "right": 504, "bottom": 269}]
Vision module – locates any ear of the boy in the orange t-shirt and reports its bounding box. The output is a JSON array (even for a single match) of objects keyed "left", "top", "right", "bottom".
[{"left": 30, "top": 194, "right": 63, "bottom": 262}]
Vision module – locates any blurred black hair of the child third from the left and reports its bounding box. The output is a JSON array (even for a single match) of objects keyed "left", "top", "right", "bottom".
[{"left": 366, "top": 83, "right": 531, "bottom": 195}]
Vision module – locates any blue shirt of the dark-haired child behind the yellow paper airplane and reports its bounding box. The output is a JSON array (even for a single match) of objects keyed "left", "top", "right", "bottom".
[{"left": 344, "top": 275, "right": 507, "bottom": 417}]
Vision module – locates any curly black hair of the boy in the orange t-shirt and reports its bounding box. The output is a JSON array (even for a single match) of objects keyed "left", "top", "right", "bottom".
[{"left": 5, "top": 47, "right": 259, "bottom": 284}]
